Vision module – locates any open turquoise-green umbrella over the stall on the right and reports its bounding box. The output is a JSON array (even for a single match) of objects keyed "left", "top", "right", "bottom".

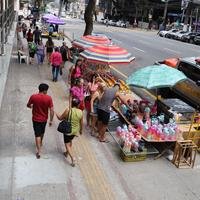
[{"left": 126, "top": 64, "right": 187, "bottom": 89}]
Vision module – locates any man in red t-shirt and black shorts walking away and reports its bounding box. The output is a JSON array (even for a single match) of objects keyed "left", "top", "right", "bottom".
[{"left": 27, "top": 83, "right": 54, "bottom": 159}]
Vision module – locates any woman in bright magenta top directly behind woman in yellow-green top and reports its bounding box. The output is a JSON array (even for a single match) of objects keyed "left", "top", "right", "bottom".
[{"left": 69, "top": 78, "right": 85, "bottom": 110}]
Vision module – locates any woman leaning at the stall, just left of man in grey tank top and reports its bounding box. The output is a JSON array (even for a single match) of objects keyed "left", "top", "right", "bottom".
[{"left": 90, "top": 83, "right": 105, "bottom": 136}]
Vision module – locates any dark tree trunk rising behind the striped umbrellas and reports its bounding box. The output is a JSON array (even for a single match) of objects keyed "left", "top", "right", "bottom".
[{"left": 83, "top": 0, "right": 96, "bottom": 35}]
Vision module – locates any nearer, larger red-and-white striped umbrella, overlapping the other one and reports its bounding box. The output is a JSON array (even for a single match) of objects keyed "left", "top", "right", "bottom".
[{"left": 80, "top": 44, "right": 135, "bottom": 64}]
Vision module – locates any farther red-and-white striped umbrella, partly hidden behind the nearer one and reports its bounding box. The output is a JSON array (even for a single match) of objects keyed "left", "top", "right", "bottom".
[{"left": 72, "top": 35, "right": 111, "bottom": 49}]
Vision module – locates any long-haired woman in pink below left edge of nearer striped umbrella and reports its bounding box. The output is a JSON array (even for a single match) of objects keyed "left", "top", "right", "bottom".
[{"left": 68, "top": 59, "right": 83, "bottom": 86}]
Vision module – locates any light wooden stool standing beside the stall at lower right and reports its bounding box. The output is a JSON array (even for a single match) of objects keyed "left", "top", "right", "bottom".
[{"left": 172, "top": 140, "right": 197, "bottom": 168}]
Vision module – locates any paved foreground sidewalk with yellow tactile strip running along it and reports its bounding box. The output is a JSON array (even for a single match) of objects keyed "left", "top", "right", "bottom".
[{"left": 0, "top": 20, "right": 200, "bottom": 200}]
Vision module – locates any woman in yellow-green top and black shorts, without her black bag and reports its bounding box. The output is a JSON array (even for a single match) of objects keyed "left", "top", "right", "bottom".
[{"left": 56, "top": 99, "right": 83, "bottom": 167}]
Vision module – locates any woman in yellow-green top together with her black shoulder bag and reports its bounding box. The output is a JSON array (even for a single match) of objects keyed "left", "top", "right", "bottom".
[{"left": 56, "top": 98, "right": 83, "bottom": 167}]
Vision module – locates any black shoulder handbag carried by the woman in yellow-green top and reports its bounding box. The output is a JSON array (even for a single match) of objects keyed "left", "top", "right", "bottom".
[{"left": 57, "top": 110, "right": 72, "bottom": 135}]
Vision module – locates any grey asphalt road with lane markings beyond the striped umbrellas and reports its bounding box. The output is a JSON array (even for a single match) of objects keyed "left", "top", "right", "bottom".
[{"left": 65, "top": 19, "right": 200, "bottom": 75}]
